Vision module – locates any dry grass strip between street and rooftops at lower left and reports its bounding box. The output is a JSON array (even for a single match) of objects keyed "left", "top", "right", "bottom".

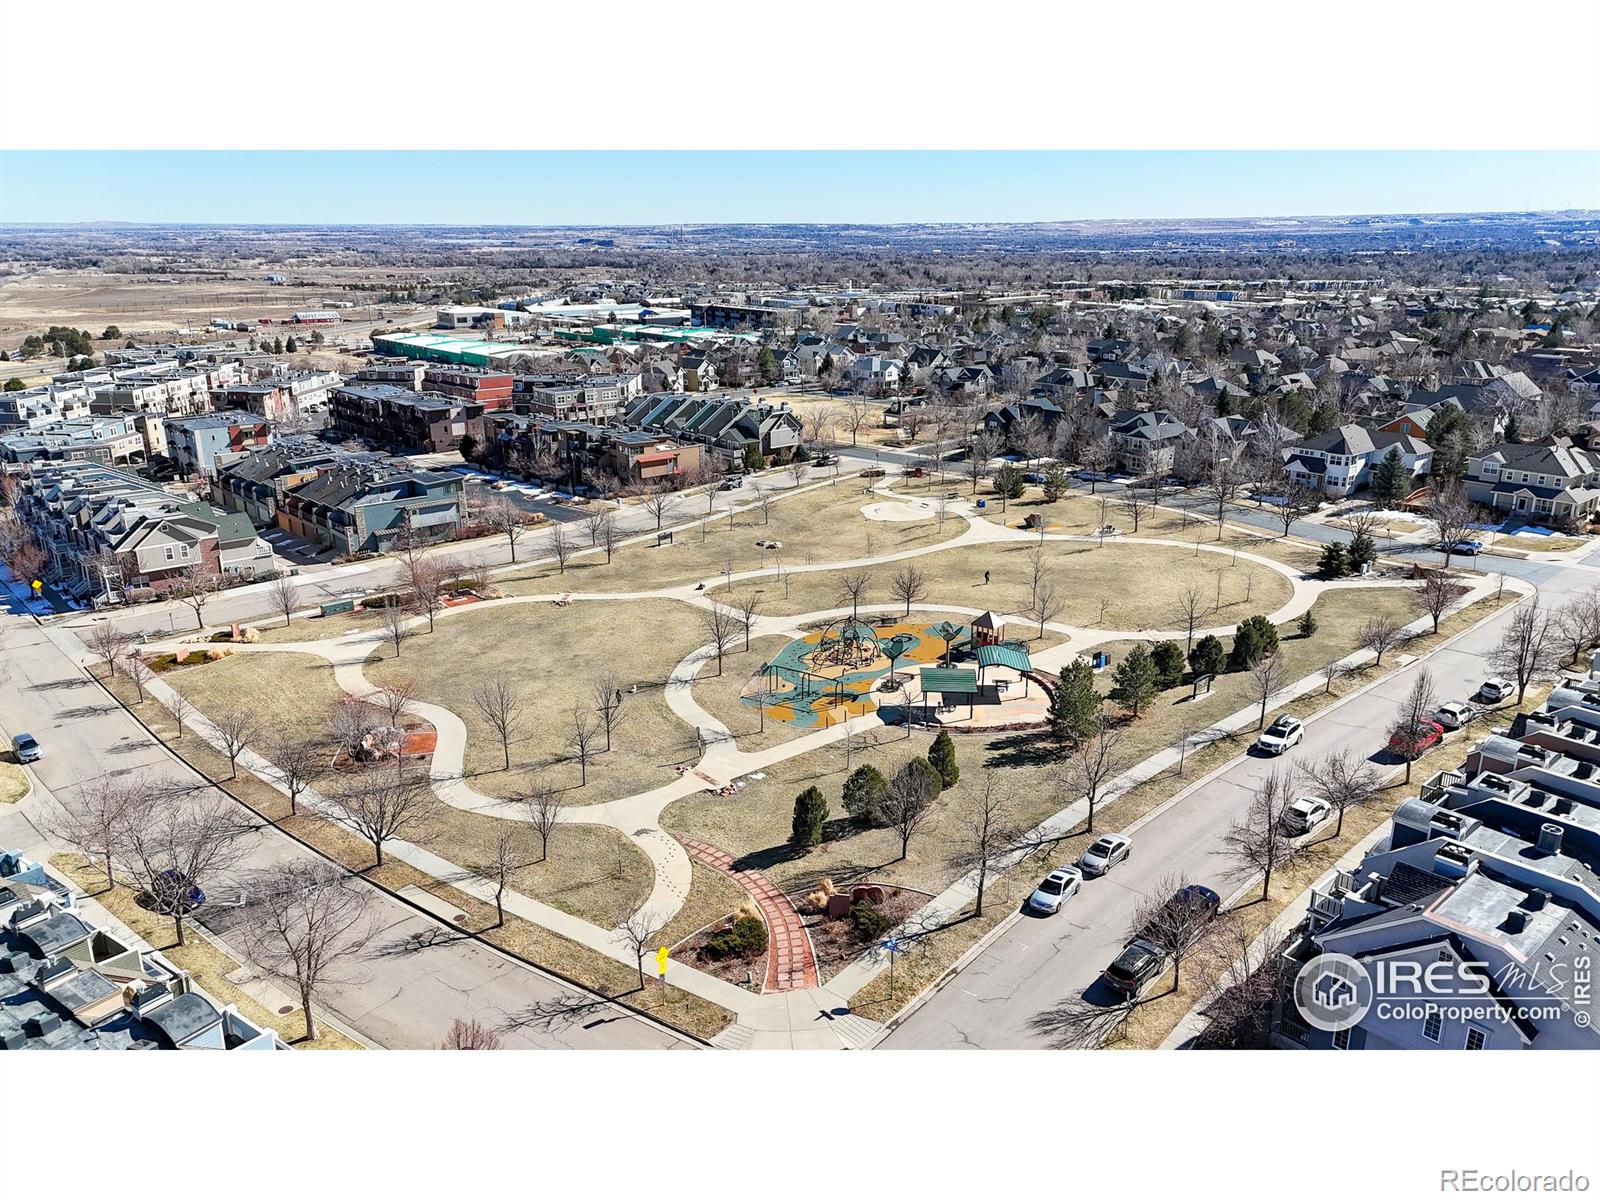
[{"left": 50, "top": 854, "right": 363, "bottom": 1050}]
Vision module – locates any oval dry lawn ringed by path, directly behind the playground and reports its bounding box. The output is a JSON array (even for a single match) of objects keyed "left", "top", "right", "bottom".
[{"left": 712, "top": 541, "right": 1294, "bottom": 640}]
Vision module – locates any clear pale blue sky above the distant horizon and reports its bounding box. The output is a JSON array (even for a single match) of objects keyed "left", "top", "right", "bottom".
[{"left": 0, "top": 150, "right": 1600, "bottom": 226}]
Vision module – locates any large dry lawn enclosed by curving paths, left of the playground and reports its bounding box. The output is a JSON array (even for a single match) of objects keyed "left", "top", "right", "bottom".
[{"left": 366, "top": 600, "right": 715, "bottom": 805}]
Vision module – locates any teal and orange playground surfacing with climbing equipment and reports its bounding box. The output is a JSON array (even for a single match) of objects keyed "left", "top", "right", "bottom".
[{"left": 741, "top": 618, "right": 973, "bottom": 730}]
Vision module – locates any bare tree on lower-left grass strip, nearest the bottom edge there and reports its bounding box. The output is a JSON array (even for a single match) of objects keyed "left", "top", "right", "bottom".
[{"left": 242, "top": 859, "right": 376, "bottom": 1042}]
